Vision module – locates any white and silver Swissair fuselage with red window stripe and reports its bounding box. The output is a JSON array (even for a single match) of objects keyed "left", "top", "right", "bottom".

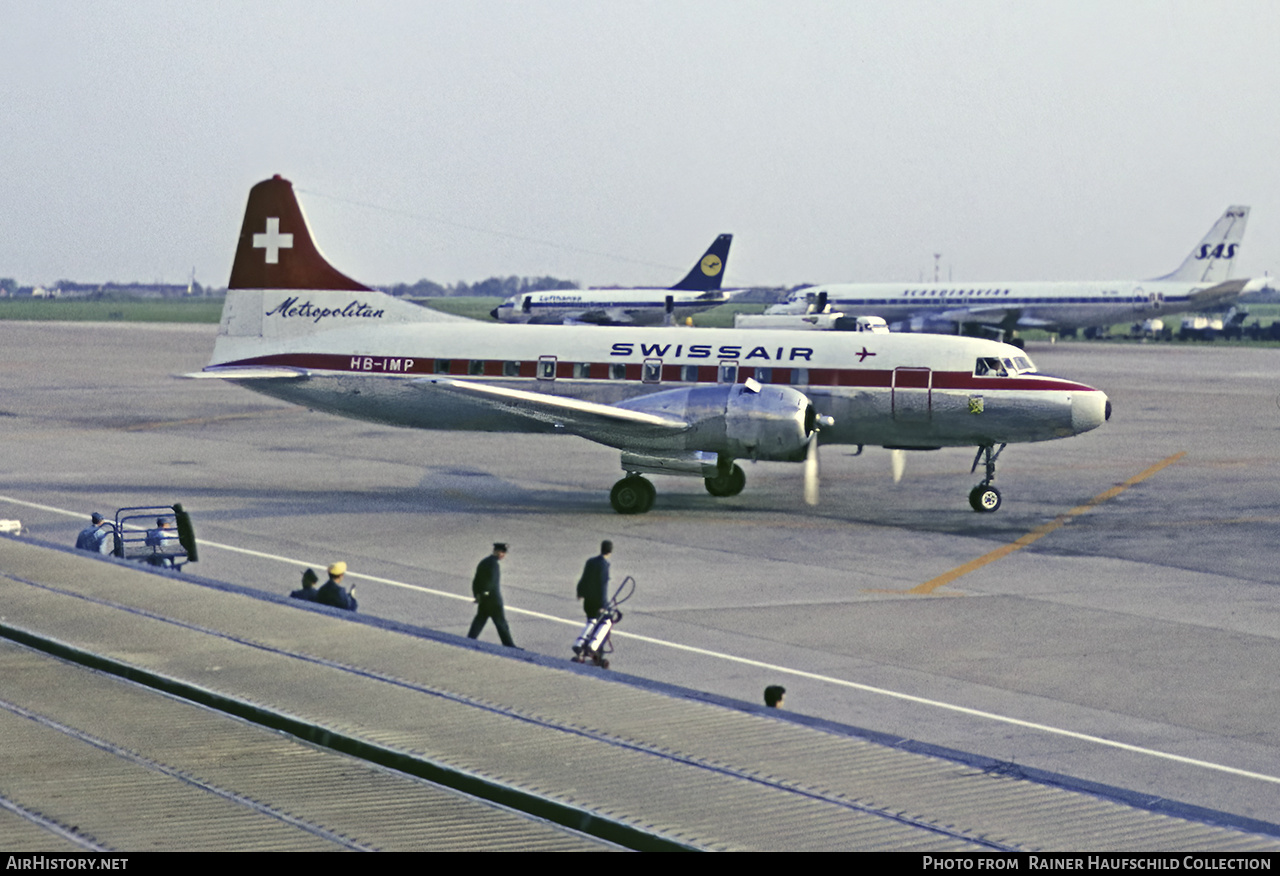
[{"left": 215, "top": 307, "right": 1106, "bottom": 447}]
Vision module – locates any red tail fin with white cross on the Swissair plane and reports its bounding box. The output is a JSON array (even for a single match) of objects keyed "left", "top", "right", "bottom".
[{"left": 227, "top": 174, "right": 369, "bottom": 291}]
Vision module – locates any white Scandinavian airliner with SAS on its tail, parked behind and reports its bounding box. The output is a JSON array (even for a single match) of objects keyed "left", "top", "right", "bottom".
[{"left": 765, "top": 206, "right": 1251, "bottom": 341}]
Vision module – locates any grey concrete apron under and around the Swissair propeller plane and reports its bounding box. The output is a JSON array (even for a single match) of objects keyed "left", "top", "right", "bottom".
[{"left": 0, "top": 323, "right": 1280, "bottom": 822}]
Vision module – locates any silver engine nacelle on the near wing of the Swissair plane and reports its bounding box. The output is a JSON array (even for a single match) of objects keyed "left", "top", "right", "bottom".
[{"left": 620, "top": 380, "right": 817, "bottom": 462}]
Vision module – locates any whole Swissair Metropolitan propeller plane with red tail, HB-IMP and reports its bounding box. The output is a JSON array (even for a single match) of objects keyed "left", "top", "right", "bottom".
[{"left": 197, "top": 177, "right": 1111, "bottom": 514}]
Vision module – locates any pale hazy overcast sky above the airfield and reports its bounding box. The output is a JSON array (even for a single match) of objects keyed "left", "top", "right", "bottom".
[{"left": 0, "top": 0, "right": 1280, "bottom": 286}]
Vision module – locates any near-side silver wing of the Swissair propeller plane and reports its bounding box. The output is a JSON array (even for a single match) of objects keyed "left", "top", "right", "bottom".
[{"left": 413, "top": 377, "right": 691, "bottom": 446}]
